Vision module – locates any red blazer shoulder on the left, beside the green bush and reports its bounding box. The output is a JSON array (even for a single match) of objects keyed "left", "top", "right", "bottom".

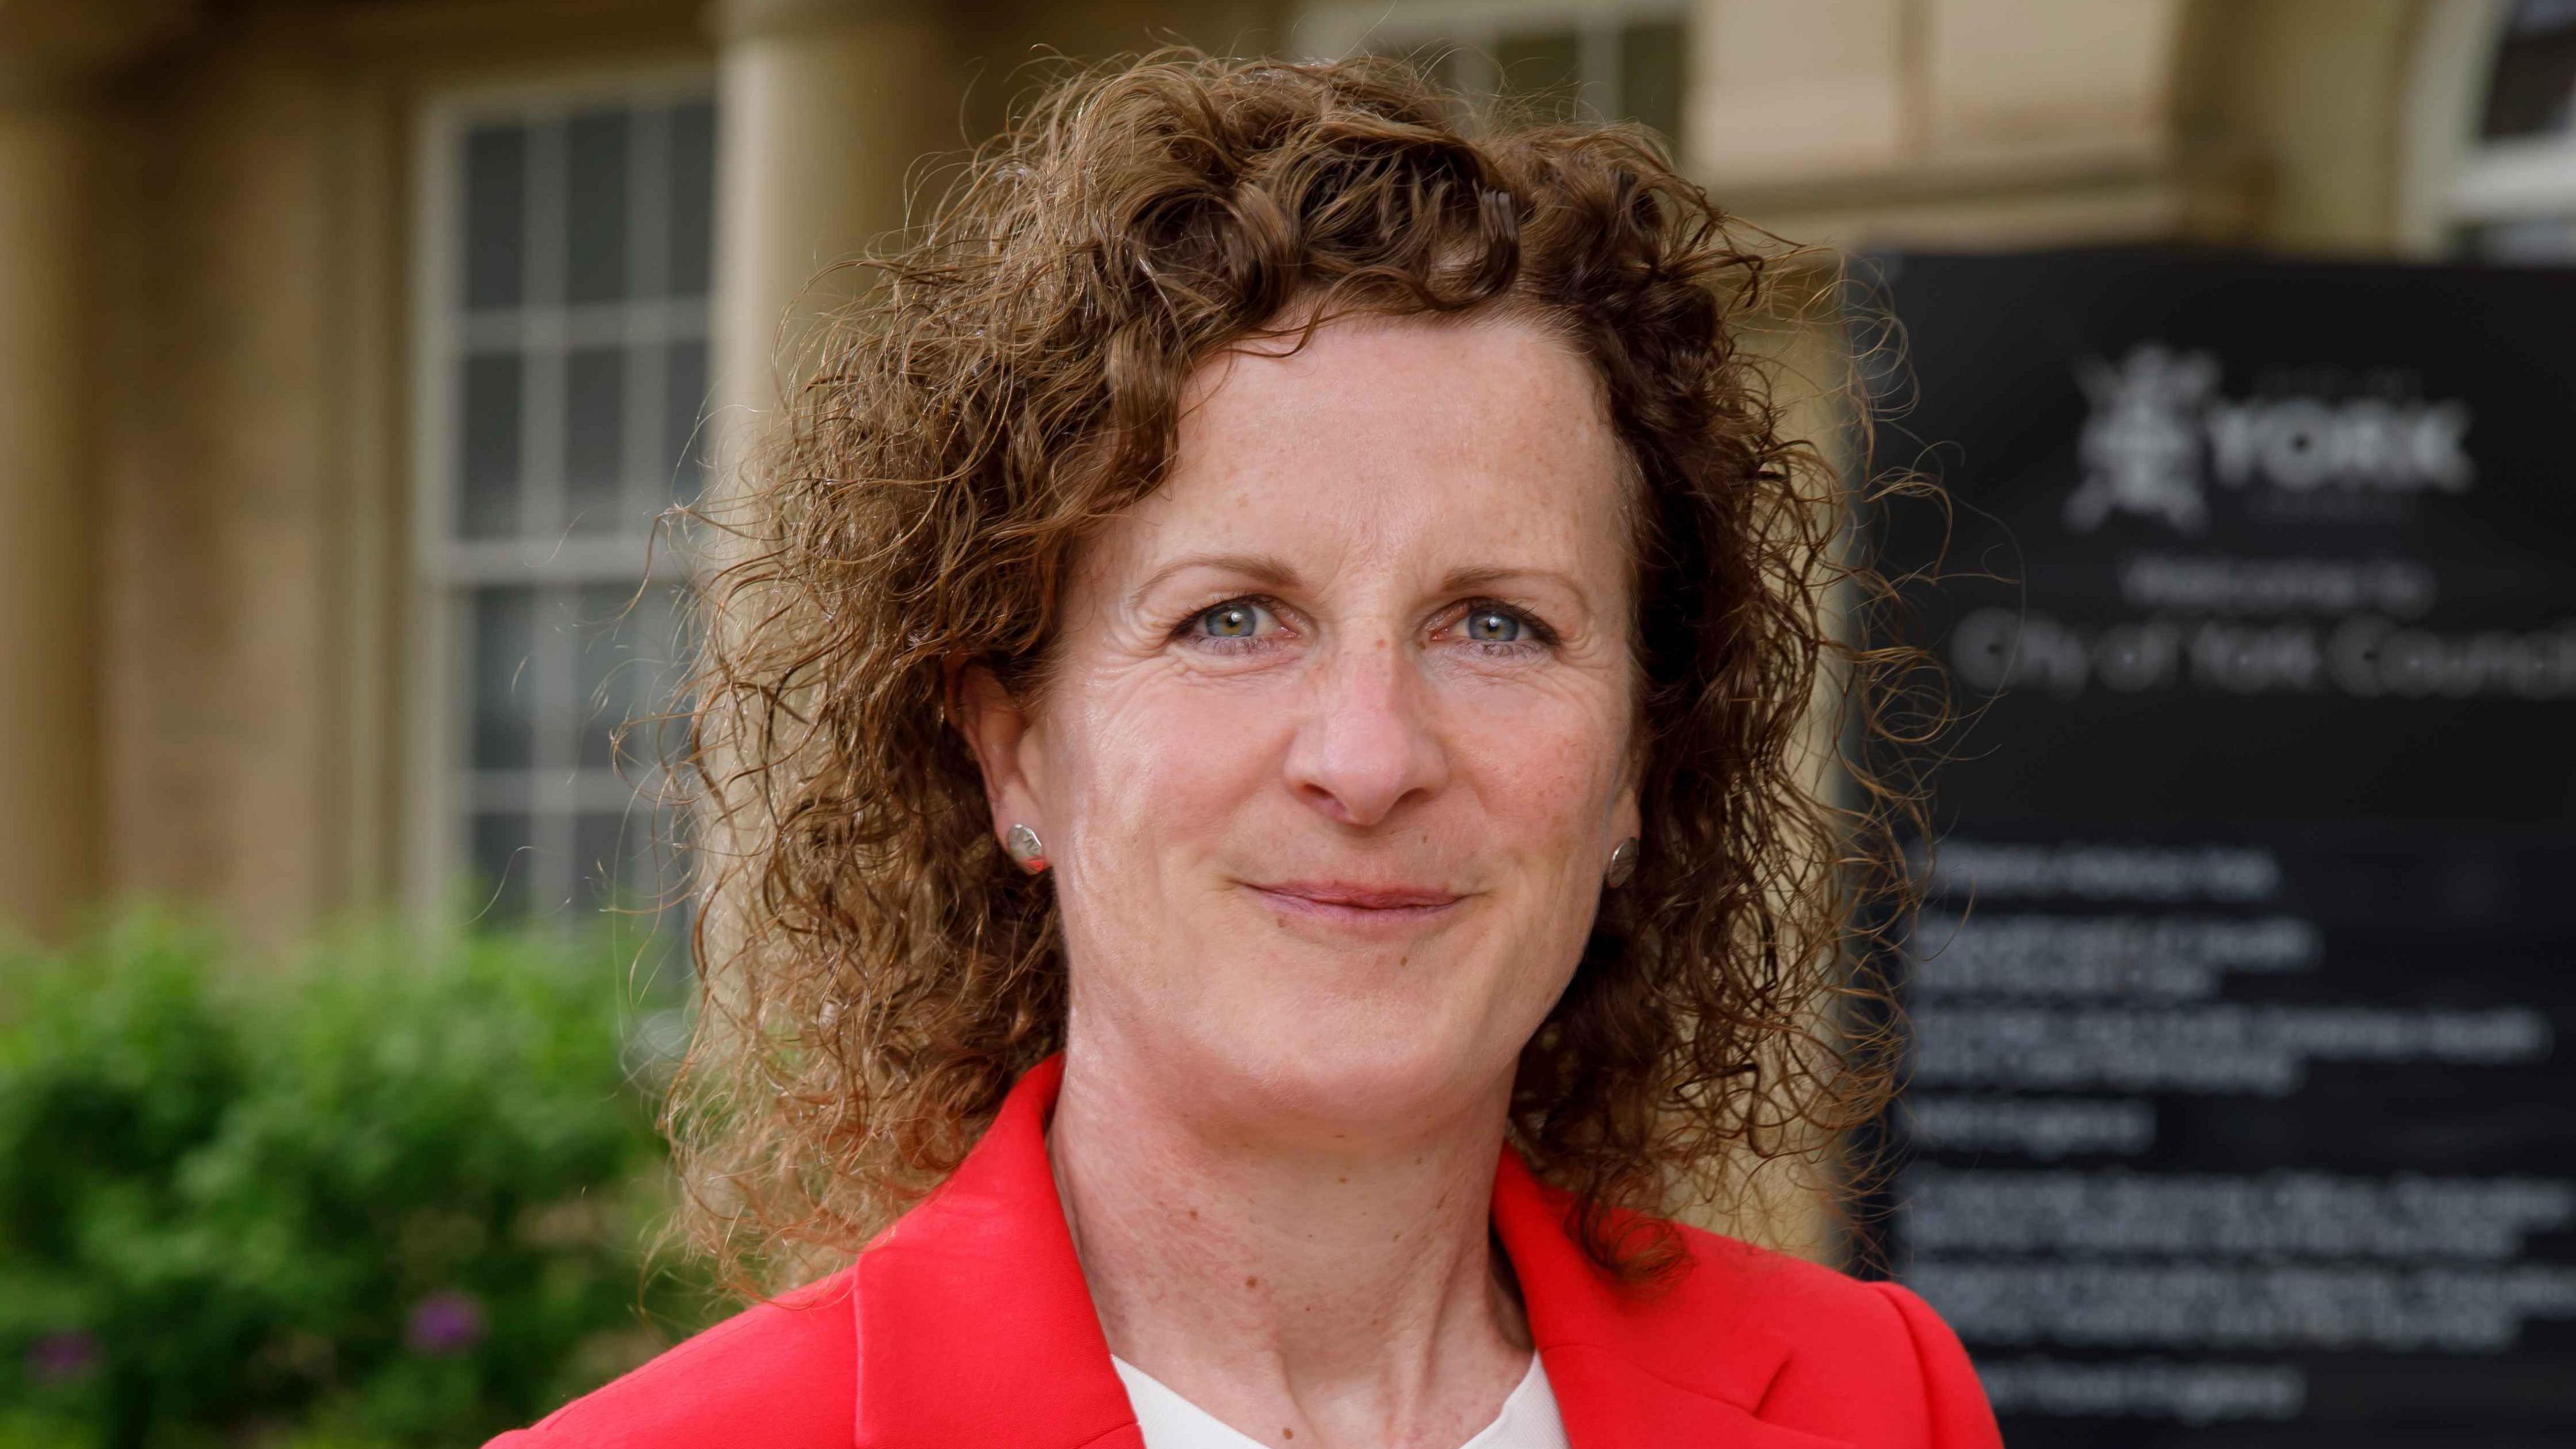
[{"left": 487, "top": 1269, "right": 858, "bottom": 1449}]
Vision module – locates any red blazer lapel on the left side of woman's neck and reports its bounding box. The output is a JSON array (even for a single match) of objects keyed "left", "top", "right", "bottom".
[{"left": 855, "top": 1057, "right": 1144, "bottom": 1449}]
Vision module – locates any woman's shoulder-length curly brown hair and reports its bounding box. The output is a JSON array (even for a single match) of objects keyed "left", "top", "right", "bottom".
[{"left": 669, "top": 52, "right": 1901, "bottom": 1281}]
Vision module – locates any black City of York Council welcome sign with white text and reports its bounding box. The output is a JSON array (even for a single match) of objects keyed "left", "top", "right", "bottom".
[{"left": 1876, "top": 253, "right": 2576, "bottom": 1449}]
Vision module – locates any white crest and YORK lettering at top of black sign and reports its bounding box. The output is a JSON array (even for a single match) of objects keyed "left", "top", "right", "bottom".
[{"left": 2066, "top": 343, "right": 2475, "bottom": 534}]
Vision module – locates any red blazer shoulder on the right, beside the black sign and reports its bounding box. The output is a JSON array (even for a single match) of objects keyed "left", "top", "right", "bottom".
[{"left": 1677, "top": 1227, "right": 2002, "bottom": 1449}]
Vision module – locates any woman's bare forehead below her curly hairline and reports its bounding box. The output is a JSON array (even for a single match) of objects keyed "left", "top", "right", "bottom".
[{"left": 1100, "top": 317, "right": 1628, "bottom": 578}]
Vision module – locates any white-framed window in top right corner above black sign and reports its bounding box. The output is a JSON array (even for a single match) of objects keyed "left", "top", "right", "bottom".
[{"left": 2442, "top": 0, "right": 2576, "bottom": 263}]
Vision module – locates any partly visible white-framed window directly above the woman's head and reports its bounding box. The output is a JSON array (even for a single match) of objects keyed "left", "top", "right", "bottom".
[{"left": 1296, "top": 0, "right": 1690, "bottom": 144}]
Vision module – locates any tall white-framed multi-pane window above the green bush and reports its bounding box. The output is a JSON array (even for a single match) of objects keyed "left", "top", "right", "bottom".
[{"left": 412, "top": 74, "right": 716, "bottom": 923}]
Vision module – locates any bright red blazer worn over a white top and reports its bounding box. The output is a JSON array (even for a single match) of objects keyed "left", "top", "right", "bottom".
[{"left": 492, "top": 1057, "right": 2002, "bottom": 1449}]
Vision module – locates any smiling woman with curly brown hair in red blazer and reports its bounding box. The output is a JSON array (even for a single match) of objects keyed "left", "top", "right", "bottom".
[{"left": 507, "top": 57, "right": 1996, "bottom": 1449}]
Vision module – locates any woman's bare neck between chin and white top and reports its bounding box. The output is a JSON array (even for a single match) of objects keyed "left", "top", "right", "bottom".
[{"left": 1049, "top": 1042, "right": 1530, "bottom": 1449}]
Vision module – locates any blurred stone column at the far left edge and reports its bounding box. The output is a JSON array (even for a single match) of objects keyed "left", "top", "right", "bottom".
[{"left": 0, "top": 0, "right": 185, "bottom": 938}]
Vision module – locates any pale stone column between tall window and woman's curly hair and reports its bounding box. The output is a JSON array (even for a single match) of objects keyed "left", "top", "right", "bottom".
[{"left": 714, "top": 0, "right": 963, "bottom": 433}]
